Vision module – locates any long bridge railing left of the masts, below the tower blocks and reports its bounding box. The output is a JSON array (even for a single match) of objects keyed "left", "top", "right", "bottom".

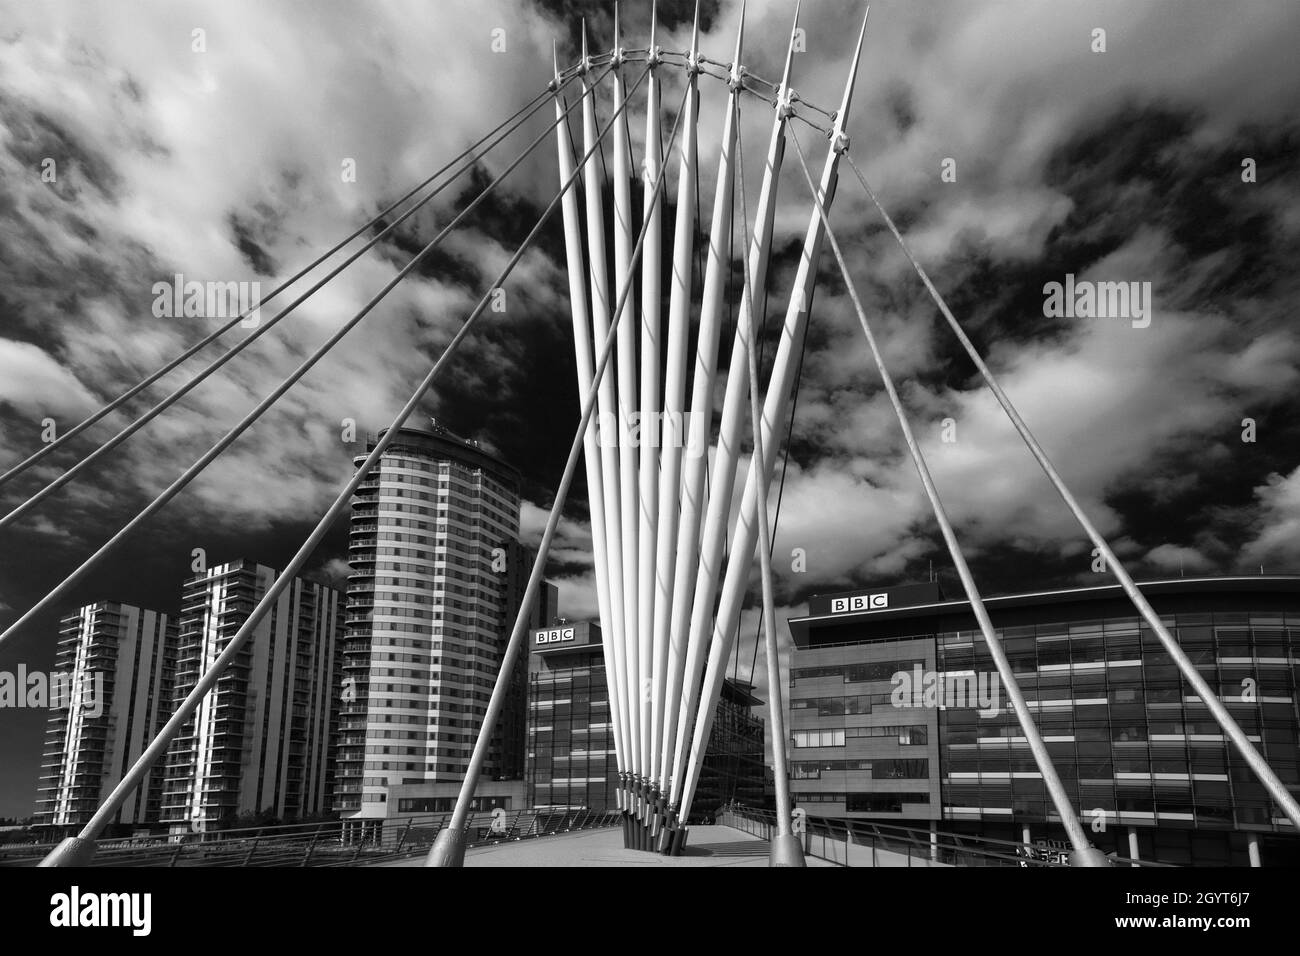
[{"left": 0, "top": 808, "right": 620, "bottom": 868}]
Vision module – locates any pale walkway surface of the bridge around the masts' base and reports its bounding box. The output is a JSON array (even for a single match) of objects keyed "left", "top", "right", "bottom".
[{"left": 377, "top": 826, "right": 833, "bottom": 866}]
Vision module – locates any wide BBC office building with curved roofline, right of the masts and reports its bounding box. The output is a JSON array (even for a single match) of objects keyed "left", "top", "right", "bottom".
[{"left": 789, "top": 575, "right": 1300, "bottom": 866}]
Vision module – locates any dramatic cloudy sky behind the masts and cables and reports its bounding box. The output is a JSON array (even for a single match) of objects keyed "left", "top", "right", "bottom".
[{"left": 0, "top": 0, "right": 1300, "bottom": 816}]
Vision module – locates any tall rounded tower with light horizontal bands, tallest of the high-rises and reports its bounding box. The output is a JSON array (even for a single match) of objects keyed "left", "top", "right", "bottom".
[{"left": 334, "top": 425, "right": 530, "bottom": 817}]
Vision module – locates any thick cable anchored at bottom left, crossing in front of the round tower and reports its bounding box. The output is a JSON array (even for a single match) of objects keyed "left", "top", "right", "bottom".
[{"left": 42, "top": 69, "right": 649, "bottom": 866}]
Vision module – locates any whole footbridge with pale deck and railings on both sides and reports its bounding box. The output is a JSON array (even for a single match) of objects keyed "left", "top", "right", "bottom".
[{"left": 0, "top": 805, "right": 1160, "bottom": 869}]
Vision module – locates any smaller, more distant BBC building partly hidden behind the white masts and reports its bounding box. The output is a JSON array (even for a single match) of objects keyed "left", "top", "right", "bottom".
[{"left": 525, "top": 620, "right": 764, "bottom": 822}]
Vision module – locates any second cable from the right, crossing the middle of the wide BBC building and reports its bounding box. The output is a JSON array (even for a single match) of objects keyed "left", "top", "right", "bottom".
[{"left": 790, "top": 130, "right": 1106, "bottom": 866}]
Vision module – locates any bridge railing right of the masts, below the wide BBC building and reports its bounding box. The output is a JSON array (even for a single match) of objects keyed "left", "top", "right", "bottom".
[{"left": 716, "top": 804, "right": 1169, "bottom": 868}]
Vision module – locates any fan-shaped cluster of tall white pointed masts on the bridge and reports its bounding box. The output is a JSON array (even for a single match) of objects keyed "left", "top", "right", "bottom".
[{"left": 555, "top": 0, "right": 861, "bottom": 837}]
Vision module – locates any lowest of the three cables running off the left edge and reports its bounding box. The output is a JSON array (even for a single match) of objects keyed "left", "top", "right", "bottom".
[{"left": 0, "top": 63, "right": 634, "bottom": 658}]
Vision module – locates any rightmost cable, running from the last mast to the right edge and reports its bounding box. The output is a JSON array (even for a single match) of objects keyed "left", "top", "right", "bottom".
[{"left": 845, "top": 153, "right": 1300, "bottom": 829}]
